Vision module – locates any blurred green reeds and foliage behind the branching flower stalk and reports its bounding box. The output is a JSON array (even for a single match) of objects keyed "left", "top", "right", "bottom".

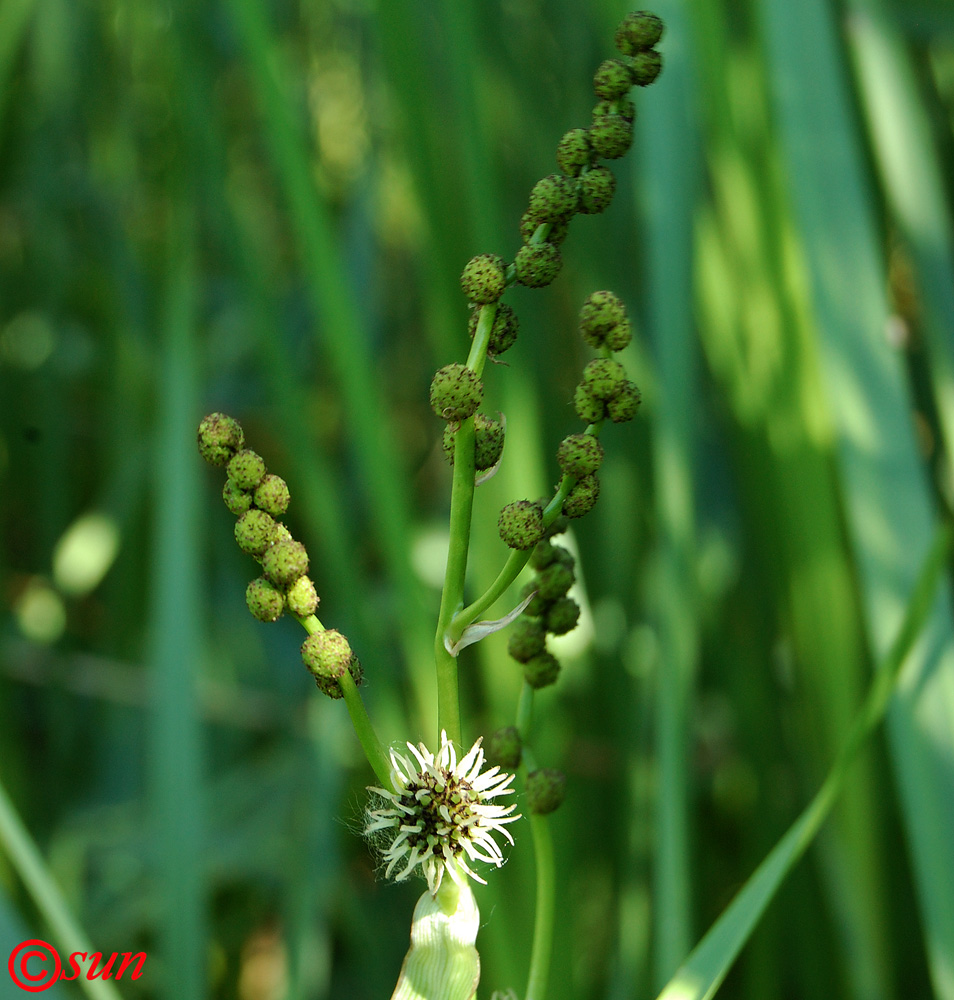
[{"left": 0, "top": 0, "right": 954, "bottom": 1000}]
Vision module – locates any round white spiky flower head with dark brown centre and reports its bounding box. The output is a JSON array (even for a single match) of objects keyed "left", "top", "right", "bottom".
[{"left": 364, "top": 732, "right": 520, "bottom": 894}]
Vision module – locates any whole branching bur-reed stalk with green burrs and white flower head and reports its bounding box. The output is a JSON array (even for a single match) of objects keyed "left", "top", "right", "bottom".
[{"left": 198, "top": 11, "right": 663, "bottom": 1000}]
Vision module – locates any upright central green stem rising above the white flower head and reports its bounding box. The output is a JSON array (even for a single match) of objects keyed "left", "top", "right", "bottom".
[{"left": 434, "top": 303, "right": 497, "bottom": 746}]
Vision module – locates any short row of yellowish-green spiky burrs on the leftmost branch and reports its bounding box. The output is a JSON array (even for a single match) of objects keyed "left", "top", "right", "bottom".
[{"left": 198, "top": 413, "right": 361, "bottom": 698}]
